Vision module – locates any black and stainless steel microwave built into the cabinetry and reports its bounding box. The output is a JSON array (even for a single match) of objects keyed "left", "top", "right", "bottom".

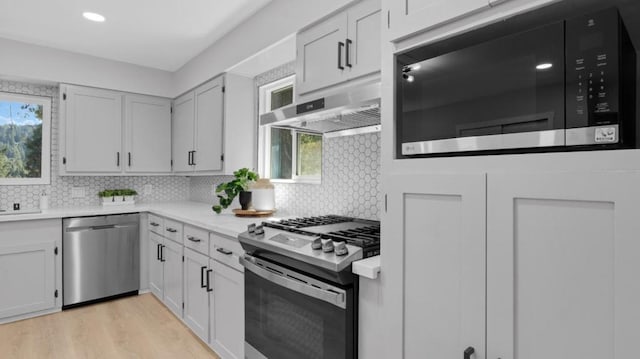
[{"left": 395, "top": 1, "right": 640, "bottom": 158}]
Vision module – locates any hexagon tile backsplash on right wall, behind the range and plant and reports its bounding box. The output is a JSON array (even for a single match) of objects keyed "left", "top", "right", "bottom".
[{"left": 189, "top": 133, "right": 382, "bottom": 220}]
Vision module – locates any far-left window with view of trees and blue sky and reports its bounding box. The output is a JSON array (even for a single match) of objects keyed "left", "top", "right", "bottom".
[{"left": 0, "top": 92, "right": 51, "bottom": 185}]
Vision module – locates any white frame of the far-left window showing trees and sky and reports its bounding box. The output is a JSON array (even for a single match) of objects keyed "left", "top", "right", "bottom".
[{"left": 0, "top": 92, "right": 51, "bottom": 186}]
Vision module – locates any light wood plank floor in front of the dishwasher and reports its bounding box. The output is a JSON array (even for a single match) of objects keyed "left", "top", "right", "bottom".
[{"left": 0, "top": 293, "right": 219, "bottom": 359}]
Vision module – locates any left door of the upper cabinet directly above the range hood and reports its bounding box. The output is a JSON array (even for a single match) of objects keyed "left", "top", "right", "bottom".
[{"left": 296, "top": 12, "right": 347, "bottom": 94}]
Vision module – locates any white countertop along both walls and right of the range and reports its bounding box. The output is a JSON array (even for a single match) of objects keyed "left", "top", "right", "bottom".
[{"left": 0, "top": 201, "right": 380, "bottom": 279}]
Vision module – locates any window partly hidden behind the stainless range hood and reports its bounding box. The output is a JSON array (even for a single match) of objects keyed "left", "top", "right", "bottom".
[{"left": 258, "top": 76, "right": 322, "bottom": 183}]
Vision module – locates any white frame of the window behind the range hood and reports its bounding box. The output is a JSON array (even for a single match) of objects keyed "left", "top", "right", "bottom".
[{"left": 258, "top": 75, "right": 324, "bottom": 184}]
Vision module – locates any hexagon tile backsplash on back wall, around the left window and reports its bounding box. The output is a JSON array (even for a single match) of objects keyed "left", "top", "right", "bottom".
[{"left": 0, "top": 80, "right": 189, "bottom": 209}]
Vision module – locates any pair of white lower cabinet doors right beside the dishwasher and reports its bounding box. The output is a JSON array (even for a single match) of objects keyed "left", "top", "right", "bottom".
[{"left": 149, "top": 232, "right": 183, "bottom": 318}]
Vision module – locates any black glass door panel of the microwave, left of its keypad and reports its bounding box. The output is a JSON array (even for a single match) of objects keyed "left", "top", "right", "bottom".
[{"left": 396, "top": 23, "right": 565, "bottom": 143}]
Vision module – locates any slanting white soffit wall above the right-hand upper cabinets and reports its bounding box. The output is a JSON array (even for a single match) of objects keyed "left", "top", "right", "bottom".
[{"left": 174, "top": 0, "right": 353, "bottom": 95}]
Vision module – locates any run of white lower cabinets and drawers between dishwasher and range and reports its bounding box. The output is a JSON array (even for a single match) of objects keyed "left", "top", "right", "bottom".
[{"left": 148, "top": 214, "right": 244, "bottom": 359}]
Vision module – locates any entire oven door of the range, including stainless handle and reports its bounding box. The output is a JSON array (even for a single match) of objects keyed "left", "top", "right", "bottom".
[{"left": 240, "top": 255, "right": 356, "bottom": 359}]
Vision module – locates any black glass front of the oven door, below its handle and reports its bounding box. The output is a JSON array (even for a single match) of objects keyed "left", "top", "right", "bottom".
[{"left": 245, "top": 270, "right": 354, "bottom": 359}]
